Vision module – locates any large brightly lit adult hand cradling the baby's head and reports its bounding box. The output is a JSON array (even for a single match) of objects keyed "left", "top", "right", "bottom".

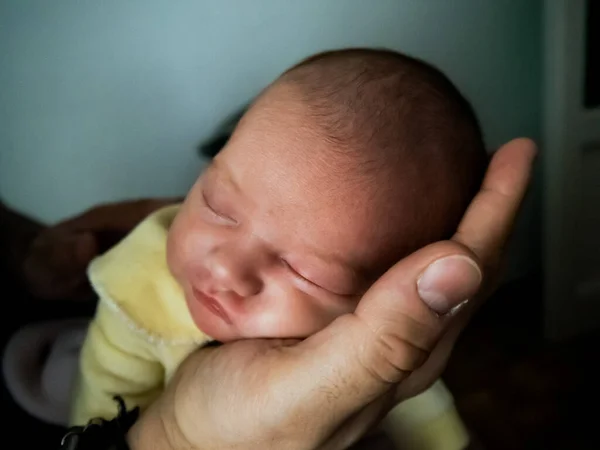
[{"left": 129, "top": 139, "right": 535, "bottom": 450}]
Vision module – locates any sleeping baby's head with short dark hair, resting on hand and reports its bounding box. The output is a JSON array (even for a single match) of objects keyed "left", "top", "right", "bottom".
[{"left": 168, "top": 49, "right": 486, "bottom": 341}]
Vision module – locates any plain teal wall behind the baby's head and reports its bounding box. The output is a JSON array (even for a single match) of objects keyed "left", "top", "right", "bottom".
[{"left": 0, "top": 0, "right": 542, "bottom": 278}]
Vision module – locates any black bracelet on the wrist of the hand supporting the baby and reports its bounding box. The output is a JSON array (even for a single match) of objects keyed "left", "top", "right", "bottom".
[{"left": 60, "top": 396, "right": 140, "bottom": 450}]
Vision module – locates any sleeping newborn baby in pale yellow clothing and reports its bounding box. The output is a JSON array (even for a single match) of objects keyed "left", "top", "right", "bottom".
[{"left": 72, "top": 49, "right": 486, "bottom": 444}]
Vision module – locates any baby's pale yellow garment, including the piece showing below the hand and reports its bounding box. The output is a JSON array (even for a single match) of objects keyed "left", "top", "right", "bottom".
[{"left": 71, "top": 206, "right": 467, "bottom": 450}]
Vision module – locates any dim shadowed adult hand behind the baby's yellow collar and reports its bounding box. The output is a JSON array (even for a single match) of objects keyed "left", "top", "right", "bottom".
[{"left": 22, "top": 199, "right": 178, "bottom": 300}]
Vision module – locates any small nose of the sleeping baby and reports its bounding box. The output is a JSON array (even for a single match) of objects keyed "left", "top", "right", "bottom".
[{"left": 207, "top": 249, "right": 263, "bottom": 298}]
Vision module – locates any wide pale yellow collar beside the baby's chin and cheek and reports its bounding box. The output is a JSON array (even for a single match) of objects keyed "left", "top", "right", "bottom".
[{"left": 88, "top": 206, "right": 205, "bottom": 344}]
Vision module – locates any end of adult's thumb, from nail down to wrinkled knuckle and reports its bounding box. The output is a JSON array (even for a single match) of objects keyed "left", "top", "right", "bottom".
[{"left": 355, "top": 242, "right": 482, "bottom": 383}]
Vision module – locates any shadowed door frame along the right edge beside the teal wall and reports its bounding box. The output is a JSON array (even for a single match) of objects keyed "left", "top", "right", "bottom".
[{"left": 541, "top": 0, "right": 600, "bottom": 339}]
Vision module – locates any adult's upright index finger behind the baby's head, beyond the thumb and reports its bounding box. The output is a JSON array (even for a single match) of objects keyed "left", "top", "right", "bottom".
[{"left": 452, "top": 138, "right": 536, "bottom": 266}]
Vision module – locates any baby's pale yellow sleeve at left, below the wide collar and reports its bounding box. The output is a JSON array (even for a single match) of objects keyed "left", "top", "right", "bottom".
[{"left": 70, "top": 300, "right": 165, "bottom": 425}]
